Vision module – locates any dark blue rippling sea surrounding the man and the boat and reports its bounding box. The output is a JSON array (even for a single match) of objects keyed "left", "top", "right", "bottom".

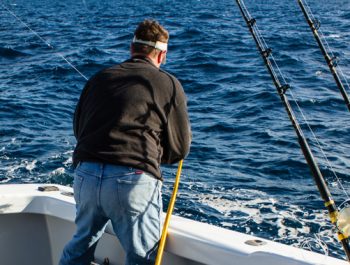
[{"left": 0, "top": 0, "right": 350, "bottom": 258}]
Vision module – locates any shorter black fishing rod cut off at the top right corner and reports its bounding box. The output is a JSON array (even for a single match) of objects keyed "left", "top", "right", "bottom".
[{"left": 298, "top": 0, "right": 350, "bottom": 111}]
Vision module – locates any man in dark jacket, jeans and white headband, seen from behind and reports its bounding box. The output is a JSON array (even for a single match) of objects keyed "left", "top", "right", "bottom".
[{"left": 59, "top": 20, "right": 191, "bottom": 265}]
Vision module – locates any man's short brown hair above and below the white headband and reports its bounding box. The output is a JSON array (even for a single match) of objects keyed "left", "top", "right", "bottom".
[{"left": 132, "top": 19, "right": 169, "bottom": 54}]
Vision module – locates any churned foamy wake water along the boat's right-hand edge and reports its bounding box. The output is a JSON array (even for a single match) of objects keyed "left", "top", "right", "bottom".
[{"left": 189, "top": 190, "right": 337, "bottom": 255}]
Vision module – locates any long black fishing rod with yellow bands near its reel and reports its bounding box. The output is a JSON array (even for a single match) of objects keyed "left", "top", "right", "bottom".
[{"left": 236, "top": 0, "right": 350, "bottom": 261}]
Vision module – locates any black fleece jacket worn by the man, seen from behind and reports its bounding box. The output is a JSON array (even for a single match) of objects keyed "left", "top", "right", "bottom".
[{"left": 73, "top": 58, "right": 191, "bottom": 179}]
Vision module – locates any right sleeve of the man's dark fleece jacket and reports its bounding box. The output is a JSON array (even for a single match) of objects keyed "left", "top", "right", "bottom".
[{"left": 162, "top": 79, "right": 192, "bottom": 164}]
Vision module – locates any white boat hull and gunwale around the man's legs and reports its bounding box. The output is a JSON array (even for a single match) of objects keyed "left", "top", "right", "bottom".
[{"left": 0, "top": 184, "right": 349, "bottom": 265}]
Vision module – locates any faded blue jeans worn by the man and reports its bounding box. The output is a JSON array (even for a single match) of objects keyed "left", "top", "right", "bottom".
[{"left": 59, "top": 162, "right": 162, "bottom": 265}]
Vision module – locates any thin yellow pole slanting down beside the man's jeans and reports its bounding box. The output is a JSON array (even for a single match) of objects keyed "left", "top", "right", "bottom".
[{"left": 154, "top": 160, "right": 183, "bottom": 265}]
